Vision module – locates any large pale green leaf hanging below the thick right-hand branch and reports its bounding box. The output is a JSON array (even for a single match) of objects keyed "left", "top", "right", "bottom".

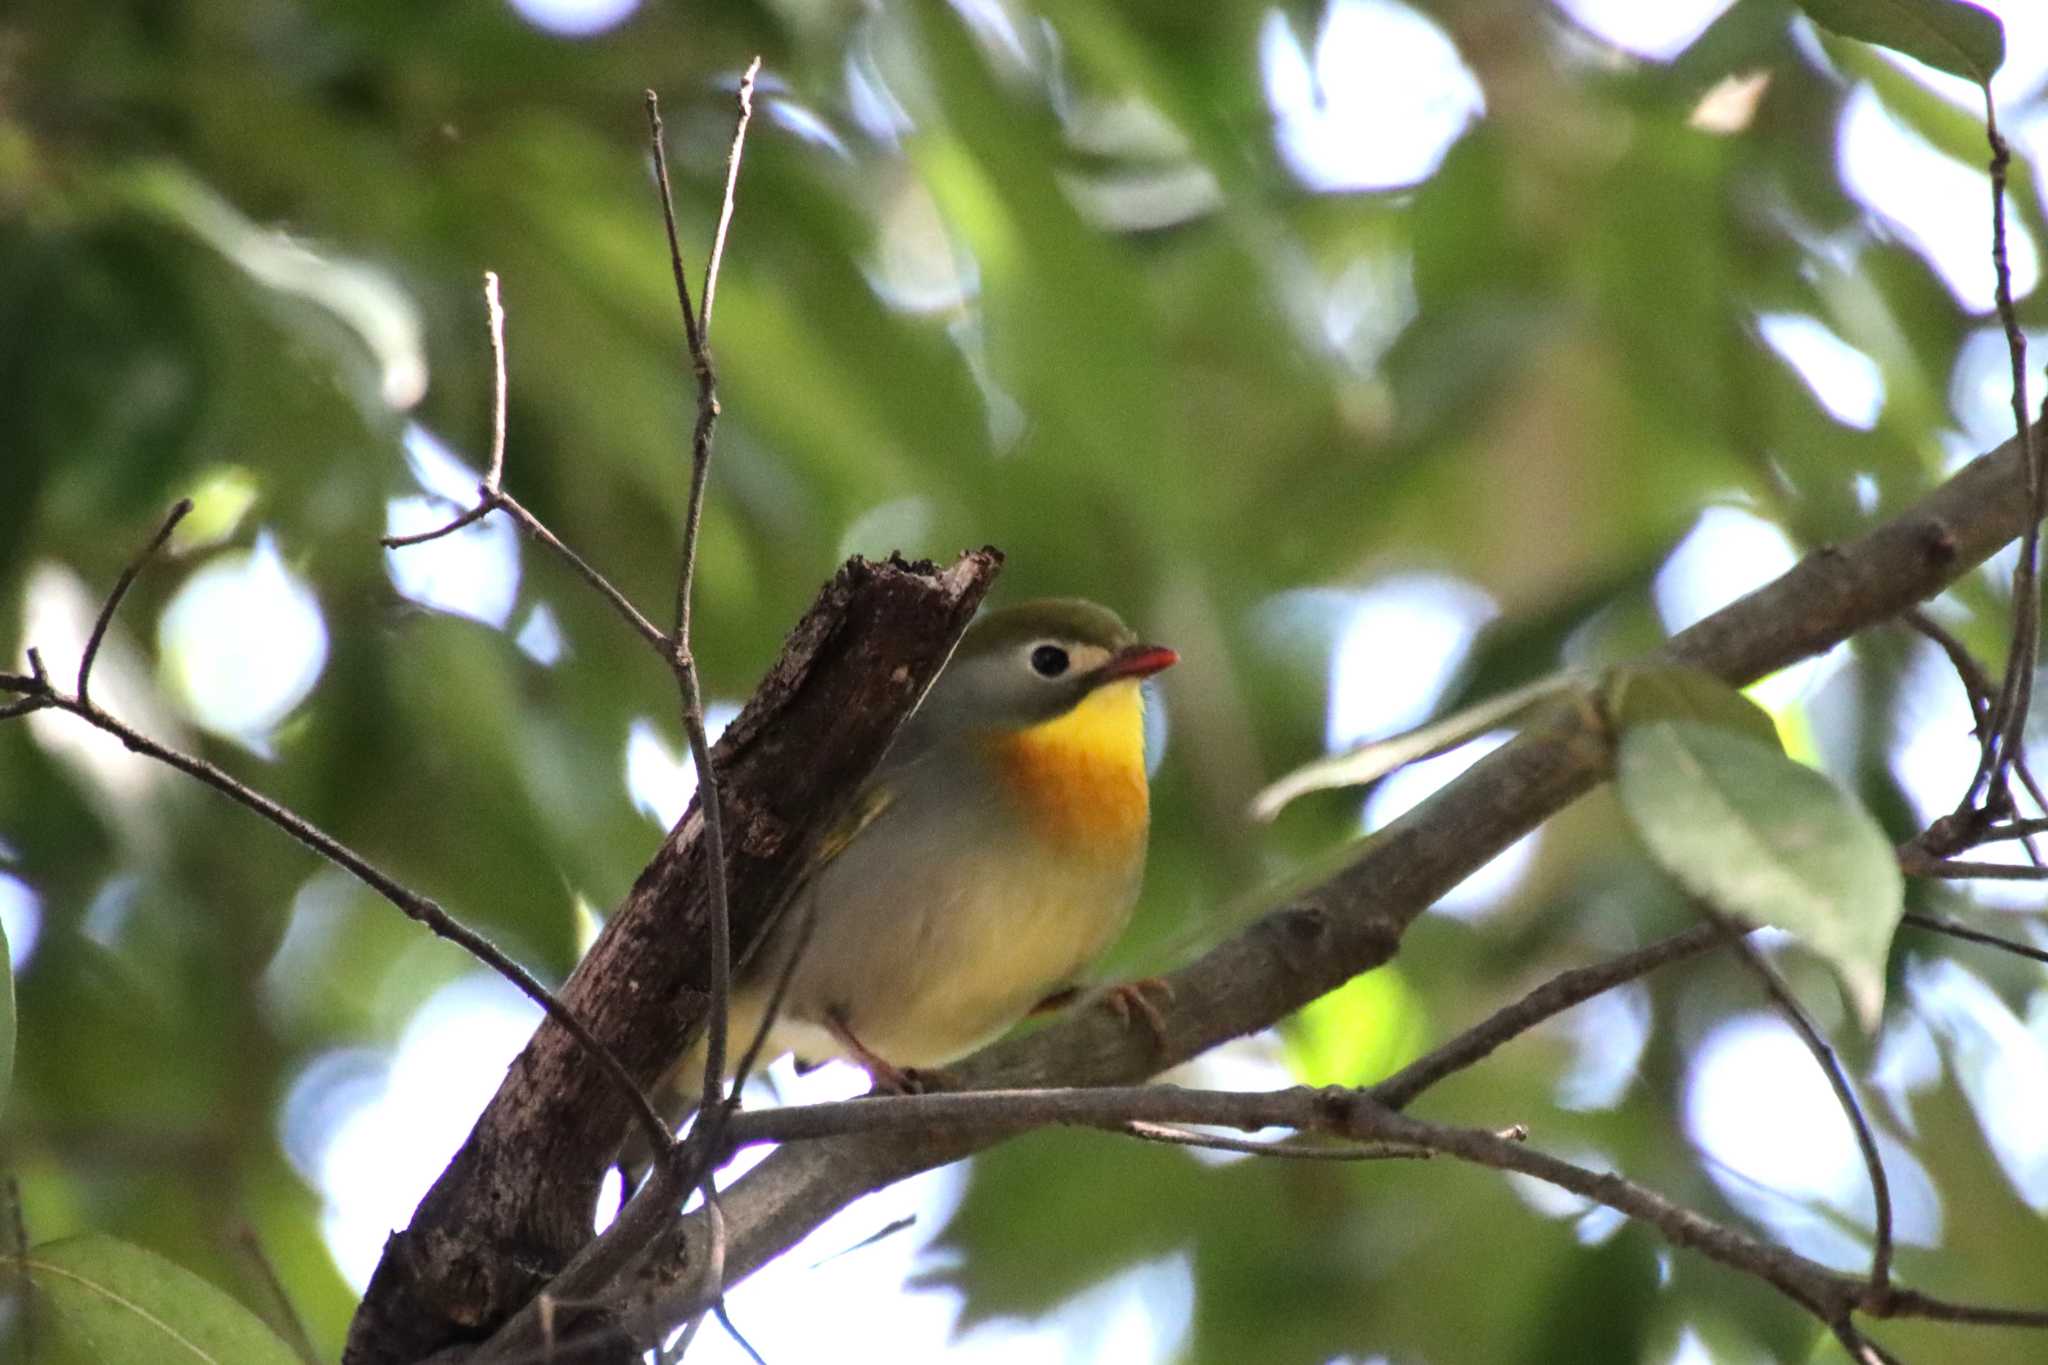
[{"left": 1616, "top": 720, "right": 1905, "bottom": 1027}]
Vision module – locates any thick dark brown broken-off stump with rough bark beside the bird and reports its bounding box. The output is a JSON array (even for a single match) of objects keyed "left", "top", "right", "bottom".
[{"left": 344, "top": 551, "right": 1001, "bottom": 1365}]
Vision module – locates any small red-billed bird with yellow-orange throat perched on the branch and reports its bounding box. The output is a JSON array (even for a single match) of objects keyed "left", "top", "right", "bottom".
[{"left": 662, "top": 598, "right": 1180, "bottom": 1111}]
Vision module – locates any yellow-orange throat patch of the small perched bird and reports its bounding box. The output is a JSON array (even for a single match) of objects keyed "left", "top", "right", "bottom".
[{"left": 991, "top": 677, "right": 1151, "bottom": 857}]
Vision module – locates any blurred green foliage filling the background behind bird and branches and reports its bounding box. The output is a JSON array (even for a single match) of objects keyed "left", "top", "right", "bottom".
[{"left": 0, "top": 0, "right": 2048, "bottom": 1363}]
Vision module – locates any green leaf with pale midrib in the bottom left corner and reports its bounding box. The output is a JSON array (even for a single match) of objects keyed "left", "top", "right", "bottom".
[{"left": 29, "top": 1232, "right": 297, "bottom": 1365}]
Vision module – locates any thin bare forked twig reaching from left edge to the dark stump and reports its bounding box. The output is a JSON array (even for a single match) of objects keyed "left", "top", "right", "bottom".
[{"left": 9, "top": 499, "right": 670, "bottom": 1150}]
